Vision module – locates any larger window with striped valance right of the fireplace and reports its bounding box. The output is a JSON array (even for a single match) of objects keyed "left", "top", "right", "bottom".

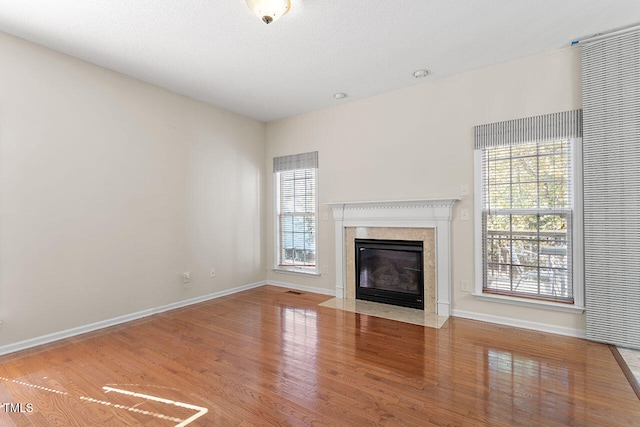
[{"left": 476, "top": 110, "right": 581, "bottom": 304}]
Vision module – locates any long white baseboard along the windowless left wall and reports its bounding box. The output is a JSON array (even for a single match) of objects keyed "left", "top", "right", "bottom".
[{"left": 0, "top": 282, "right": 266, "bottom": 356}]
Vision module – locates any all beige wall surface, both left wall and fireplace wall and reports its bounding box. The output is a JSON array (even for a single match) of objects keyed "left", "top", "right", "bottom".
[{"left": 0, "top": 33, "right": 584, "bottom": 352}]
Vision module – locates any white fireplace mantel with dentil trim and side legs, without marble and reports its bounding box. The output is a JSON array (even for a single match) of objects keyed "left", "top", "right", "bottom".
[{"left": 328, "top": 198, "right": 459, "bottom": 316}]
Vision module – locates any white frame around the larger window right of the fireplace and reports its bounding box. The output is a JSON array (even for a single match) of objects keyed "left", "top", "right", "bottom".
[{"left": 473, "top": 137, "right": 584, "bottom": 312}]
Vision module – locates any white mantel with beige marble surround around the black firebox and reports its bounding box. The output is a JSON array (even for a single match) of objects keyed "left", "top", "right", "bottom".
[{"left": 328, "top": 199, "right": 458, "bottom": 316}]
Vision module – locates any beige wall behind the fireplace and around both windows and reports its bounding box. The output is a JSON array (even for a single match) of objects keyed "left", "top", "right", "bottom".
[{"left": 265, "top": 48, "right": 584, "bottom": 330}]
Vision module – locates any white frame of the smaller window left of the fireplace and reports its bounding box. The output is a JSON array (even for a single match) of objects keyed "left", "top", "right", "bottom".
[{"left": 273, "top": 167, "right": 319, "bottom": 276}]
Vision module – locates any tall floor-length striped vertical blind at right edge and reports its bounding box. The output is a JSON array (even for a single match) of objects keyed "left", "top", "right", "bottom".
[{"left": 582, "top": 29, "right": 640, "bottom": 349}]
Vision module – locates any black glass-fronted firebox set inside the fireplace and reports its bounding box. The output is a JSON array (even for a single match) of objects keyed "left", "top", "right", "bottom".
[{"left": 355, "top": 239, "right": 424, "bottom": 310}]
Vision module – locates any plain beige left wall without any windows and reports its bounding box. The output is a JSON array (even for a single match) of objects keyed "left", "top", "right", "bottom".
[{"left": 0, "top": 33, "right": 265, "bottom": 345}]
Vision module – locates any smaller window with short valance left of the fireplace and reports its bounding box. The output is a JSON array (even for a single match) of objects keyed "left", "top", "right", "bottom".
[{"left": 274, "top": 152, "right": 318, "bottom": 274}]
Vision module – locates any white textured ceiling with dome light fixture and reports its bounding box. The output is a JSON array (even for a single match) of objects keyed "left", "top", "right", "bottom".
[{"left": 0, "top": 0, "right": 640, "bottom": 121}]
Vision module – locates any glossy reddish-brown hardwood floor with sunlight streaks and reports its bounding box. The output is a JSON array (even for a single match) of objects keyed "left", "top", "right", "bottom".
[{"left": 0, "top": 286, "right": 640, "bottom": 426}]
